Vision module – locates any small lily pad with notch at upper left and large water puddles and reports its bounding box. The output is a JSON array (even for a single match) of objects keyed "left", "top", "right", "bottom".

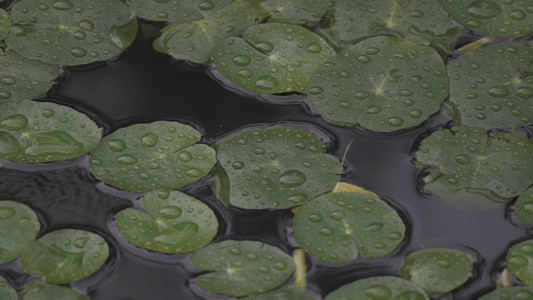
[{"left": 116, "top": 191, "right": 218, "bottom": 253}]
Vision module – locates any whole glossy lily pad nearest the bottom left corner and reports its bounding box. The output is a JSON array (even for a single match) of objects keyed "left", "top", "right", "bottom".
[{"left": 20, "top": 229, "right": 109, "bottom": 284}]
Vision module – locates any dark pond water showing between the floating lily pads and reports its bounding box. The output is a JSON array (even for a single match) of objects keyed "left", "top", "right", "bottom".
[{"left": 0, "top": 18, "right": 531, "bottom": 300}]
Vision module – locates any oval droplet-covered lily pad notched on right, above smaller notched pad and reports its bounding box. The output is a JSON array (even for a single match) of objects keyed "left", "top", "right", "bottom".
[{"left": 89, "top": 121, "right": 216, "bottom": 192}]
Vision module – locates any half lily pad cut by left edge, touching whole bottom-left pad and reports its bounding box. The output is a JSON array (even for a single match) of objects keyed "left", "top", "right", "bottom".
[{"left": 0, "top": 201, "right": 41, "bottom": 264}]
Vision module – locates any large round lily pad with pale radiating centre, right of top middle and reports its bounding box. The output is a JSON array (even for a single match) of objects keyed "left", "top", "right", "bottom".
[{"left": 306, "top": 36, "right": 448, "bottom": 132}]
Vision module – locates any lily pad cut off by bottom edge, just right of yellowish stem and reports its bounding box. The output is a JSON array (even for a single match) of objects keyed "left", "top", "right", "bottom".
[{"left": 324, "top": 276, "right": 429, "bottom": 300}]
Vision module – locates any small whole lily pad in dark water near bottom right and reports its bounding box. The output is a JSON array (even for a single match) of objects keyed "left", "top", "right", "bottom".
[{"left": 400, "top": 248, "right": 474, "bottom": 296}]
